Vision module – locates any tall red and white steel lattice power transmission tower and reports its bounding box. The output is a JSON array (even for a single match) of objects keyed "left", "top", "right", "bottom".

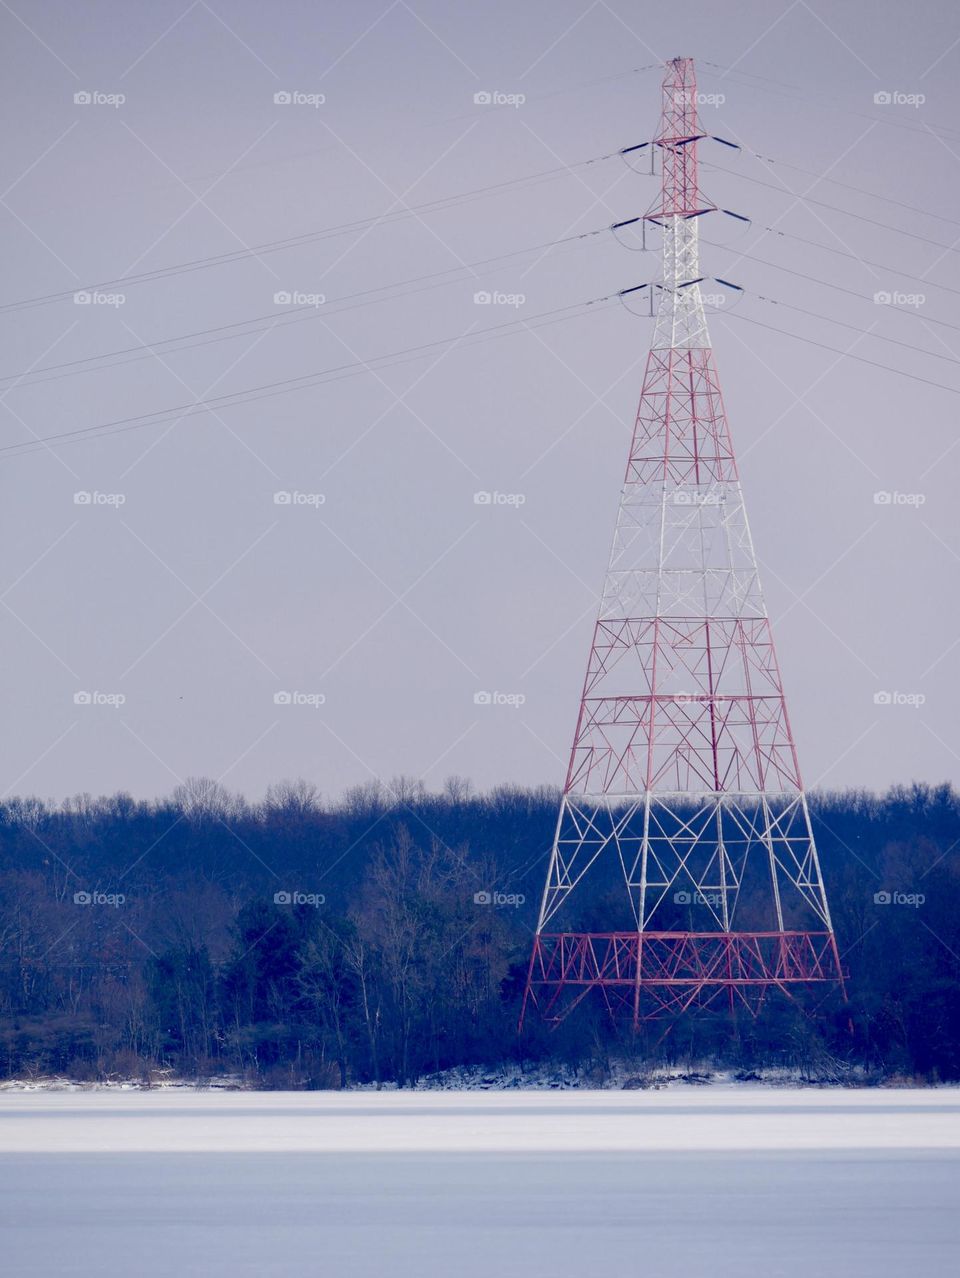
[{"left": 522, "top": 58, "right": 842, "bottom": 1024}]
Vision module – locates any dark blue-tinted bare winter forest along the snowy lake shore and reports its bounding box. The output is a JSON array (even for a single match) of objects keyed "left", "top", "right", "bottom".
[{"left": 0, "top": 777, "right": 960, "bottom": 1088}]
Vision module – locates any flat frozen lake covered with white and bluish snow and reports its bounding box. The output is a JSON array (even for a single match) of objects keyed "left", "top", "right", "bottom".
[{"left": 0, "top": 1086, "right": 960, "bottom": 1278}]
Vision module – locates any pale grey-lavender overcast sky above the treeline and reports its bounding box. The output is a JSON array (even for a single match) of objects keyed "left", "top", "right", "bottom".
[{"left": 0, "top": 0, "right": 960, "bottom": 799}]
